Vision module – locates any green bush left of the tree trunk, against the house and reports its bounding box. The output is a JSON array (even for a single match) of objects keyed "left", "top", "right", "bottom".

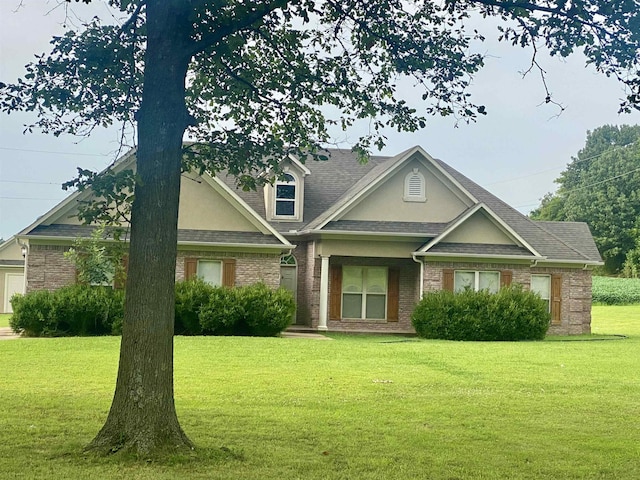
[{"left": 10, "top": 285, "right": 124, "bottom": 337}]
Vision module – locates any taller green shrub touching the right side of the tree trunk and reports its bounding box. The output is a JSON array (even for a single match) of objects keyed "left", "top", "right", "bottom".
[{"left": 174, "top": 277, "right": 215, "bottom": 335}]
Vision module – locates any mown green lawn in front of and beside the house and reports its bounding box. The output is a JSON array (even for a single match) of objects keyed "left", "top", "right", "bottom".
[{"left": 0, "top": 306, "right": 640, "bottom": 479}]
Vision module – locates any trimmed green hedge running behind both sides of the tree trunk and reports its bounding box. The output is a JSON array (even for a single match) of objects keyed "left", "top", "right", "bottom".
[{"left": 9, "top": 279, "right": 296, "bottom": 337}]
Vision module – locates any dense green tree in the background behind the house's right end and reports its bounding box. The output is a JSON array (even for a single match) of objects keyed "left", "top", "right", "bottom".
[{"left": 530, "top": 125, "right": 640, "bottom": 273}]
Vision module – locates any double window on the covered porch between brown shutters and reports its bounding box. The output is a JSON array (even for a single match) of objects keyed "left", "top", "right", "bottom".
[{"left": 342, "top": 267, "right": 387, "bottom": 320}]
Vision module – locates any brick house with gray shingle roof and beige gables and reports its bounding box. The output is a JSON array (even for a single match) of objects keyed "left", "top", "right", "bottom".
[{"left": 18, "top": 147, "right": 602, "bottom": 334}]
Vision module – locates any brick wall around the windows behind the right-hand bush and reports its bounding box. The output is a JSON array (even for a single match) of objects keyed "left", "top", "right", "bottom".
[{"left": 423, "top": 262, "right": 591, "bottom": 335}]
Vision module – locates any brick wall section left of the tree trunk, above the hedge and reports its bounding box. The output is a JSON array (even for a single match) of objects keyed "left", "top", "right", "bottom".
[{"left": 26, "top": 245, "right": 76, "bottom": 292}]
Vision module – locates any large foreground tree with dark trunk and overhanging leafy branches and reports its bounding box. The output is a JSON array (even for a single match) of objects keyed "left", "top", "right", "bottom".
[{"left": 0, "top": 0, "right": 640, "bottom": 458}]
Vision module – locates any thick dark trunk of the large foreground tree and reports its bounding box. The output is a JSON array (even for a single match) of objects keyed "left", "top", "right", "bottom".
[{"left": 87, "top": 0, "right": 192, "bottom": 455}]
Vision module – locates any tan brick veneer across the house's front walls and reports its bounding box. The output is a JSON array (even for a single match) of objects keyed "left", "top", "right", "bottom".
[{"left": 26, "top": 242, "right": 591, "bottom": 335}]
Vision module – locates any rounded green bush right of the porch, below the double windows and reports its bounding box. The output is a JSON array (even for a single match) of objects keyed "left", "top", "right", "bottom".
[{"left": 411, "top": 285, "right": 550, "bottom": 341}]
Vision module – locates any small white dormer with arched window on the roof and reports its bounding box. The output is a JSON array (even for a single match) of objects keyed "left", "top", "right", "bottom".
[{"left": 264, "top": 157, "right": 311, "bottom": 222}]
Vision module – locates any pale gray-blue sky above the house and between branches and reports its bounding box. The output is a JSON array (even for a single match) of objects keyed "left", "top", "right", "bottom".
[{"left": 0, "top": 0, "right": 640, "bottom": 239}]
